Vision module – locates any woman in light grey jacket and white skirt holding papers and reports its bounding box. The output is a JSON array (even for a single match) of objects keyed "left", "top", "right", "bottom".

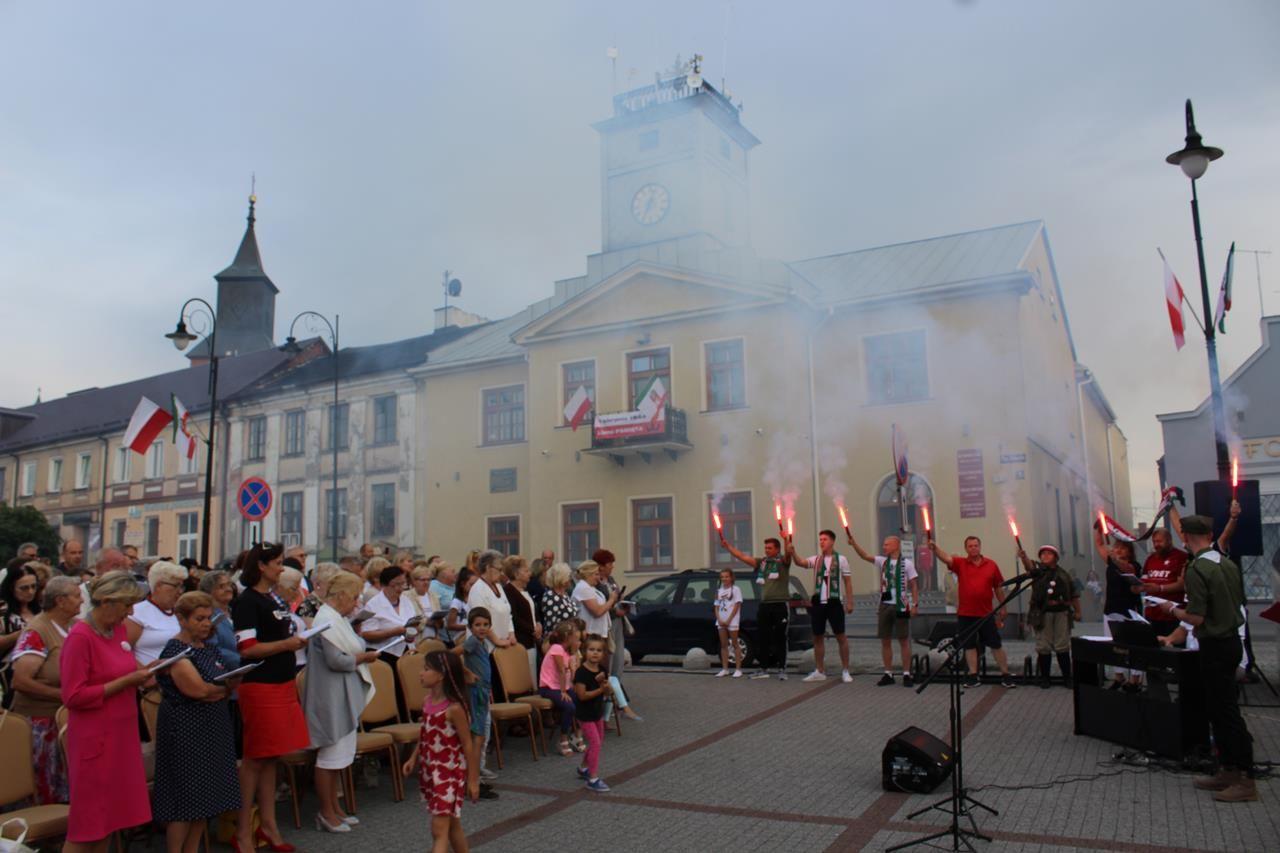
[{"left": 302, "top": 571, "right": 385, "bottom": 833}]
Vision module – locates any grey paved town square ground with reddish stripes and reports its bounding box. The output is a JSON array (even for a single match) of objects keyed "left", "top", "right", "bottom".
[{"left": 267, "top": 628, "right": 1280, "bottom": 853}]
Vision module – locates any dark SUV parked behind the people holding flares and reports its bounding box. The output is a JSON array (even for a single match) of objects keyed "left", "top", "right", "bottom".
[{"left": 627, "top": 569, "right": 813, "bottom": 663}]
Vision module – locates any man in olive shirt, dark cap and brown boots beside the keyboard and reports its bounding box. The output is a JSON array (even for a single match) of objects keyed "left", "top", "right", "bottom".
[{"left": 1161, "top": 515, "right": 1258, "bottom": 803}]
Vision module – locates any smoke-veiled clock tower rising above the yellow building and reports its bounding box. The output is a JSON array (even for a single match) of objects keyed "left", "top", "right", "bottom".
[{"left": 595, "top": 58, "right": 760, "bottom": 252}]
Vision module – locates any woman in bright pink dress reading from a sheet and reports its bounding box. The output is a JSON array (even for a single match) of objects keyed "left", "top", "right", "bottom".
[{"left": 59, "top": 571, "right": 151, "bottom": 853}]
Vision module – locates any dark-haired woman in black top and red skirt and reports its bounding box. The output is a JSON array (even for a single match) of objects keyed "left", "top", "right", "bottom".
[{"left": 232, "top": 542, "right": 310, "bottom": 853}]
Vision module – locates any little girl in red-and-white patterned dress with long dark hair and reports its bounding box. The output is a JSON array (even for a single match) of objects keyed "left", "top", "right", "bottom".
[{"left": 402, "top": 652, "right": 480, "bottom": 853}]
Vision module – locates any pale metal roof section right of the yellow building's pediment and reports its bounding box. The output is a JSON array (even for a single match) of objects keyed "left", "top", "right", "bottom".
[{"left": 790, "top": 220, "right": 1044, "bottom": 304}]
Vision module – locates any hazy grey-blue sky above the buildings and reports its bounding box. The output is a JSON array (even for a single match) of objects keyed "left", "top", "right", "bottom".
[{"left": 0, "top": 0, "right": 1280, "bottom": 507}]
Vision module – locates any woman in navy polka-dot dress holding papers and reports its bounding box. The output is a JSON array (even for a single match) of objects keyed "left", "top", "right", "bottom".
[{"left": 151, "top": 592, "right": 241, "bottom": 853}]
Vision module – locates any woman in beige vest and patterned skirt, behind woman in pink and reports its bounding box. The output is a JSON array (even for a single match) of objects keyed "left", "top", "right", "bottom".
[{"left": 12, "top": 576, "right": 81, "bottom": 806}]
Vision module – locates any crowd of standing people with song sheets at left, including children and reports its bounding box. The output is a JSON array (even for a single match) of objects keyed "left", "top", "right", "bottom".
[{"left": 0, "top": 543, "right": 641, "bottom": 853}]
